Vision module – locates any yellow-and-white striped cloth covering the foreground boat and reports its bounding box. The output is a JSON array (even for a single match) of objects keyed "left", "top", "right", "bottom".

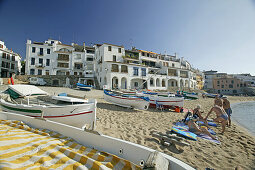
[{"left": 0, "top": 120, "right": 141, "bottom": 170}]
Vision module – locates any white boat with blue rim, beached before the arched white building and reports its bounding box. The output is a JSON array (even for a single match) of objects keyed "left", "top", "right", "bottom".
[{"left": 104, "top": 89, "right": 149, "bottom": 110}]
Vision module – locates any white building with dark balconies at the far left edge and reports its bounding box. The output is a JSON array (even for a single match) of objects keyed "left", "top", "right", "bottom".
[{"left": 0, "top": 41, "right": 21, "bottom": 77}]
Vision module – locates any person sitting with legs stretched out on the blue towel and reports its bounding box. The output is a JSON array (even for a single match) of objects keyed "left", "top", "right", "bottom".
[{"left": 186, "top": 117, "right": 216, "bottom": 140}]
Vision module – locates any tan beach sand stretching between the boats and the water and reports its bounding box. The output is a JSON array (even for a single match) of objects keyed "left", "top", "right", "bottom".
[{"left": 0, "top": 86, "right": 255, "bottom": 169}]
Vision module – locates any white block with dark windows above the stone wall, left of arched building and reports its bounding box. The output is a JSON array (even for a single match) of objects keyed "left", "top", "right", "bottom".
[{"left": 26, "top": 39, "right": 95, "bottom": 83}]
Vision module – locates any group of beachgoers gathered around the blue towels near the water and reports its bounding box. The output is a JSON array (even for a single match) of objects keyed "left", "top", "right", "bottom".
[{"left": 185, "top": 95, "right": 232, "bottom": 139}]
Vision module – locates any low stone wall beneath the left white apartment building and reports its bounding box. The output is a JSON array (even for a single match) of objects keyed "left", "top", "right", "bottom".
[{"left": 15, "top": 75, "right": 84, "bottom": 87}]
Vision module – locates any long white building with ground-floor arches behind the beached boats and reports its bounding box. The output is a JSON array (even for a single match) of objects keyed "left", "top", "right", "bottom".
[{"left": 95, "top": 43, "right": 196, "bottom": 90}]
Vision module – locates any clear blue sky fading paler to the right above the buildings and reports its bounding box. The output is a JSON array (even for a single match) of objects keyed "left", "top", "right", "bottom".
[{"left": 0, "top": 0, "right": 255, "bottom": 75}]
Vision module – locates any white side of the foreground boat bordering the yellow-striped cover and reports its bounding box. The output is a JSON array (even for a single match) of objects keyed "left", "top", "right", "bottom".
[{"left": 0, "top": 112, "right": 194, "bottom": 170}]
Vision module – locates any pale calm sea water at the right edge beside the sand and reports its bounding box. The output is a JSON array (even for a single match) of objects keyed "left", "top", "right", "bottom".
[{"left": 231, "top": 102, "right": 255, "bottom": 136}]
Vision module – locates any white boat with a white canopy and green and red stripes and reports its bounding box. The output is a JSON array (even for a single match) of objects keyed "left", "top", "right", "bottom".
[{"left": 0, "top": 84, "right": 97, "bottom": 129}]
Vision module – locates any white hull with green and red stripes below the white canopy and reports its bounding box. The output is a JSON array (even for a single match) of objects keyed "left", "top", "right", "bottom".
[{"left": 0, "top": 99, "right": 96, "bottom": 129}]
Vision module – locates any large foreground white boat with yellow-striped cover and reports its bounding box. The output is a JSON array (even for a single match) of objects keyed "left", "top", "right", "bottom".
[{"left": 0, "top": 112, "right": 194, "bottom": 170}]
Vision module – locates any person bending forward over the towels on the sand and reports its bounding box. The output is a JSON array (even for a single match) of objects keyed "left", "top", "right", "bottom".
[{"left": 205, "top": 105, "right": 228, "bottom": 134}]
